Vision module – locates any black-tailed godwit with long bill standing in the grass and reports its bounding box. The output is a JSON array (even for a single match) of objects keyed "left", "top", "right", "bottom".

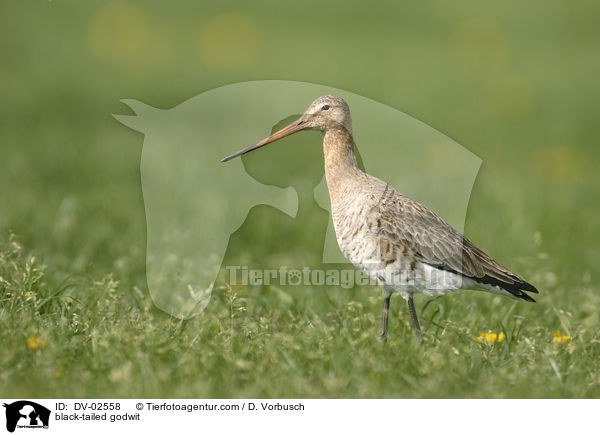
[{"left": 221, "top": 95, "right": 539, "bottom": 342}]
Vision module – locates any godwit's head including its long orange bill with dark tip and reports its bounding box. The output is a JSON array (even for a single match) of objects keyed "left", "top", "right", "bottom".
[{"left": 221, "top": 95, "right": 352, "bottom": 162}]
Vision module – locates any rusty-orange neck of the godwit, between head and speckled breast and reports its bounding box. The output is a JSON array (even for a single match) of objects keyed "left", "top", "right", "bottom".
[{"left": 323, "top": 128, "right": 363, "bottom": 205}]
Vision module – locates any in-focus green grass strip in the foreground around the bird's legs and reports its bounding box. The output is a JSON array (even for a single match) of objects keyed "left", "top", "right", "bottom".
[{"left": 0, "top": 238, "right": 600, "bottom": 398}]
